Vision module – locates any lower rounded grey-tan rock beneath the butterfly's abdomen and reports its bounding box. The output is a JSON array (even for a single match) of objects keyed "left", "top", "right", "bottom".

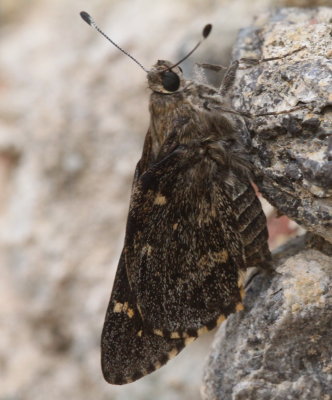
[{"left": 202, "top": 234, "right": 332, "bottom": 400}]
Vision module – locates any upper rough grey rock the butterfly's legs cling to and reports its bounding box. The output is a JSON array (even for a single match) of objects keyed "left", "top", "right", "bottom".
[{"left": 234, "top": 7, "right": 332, "bottom": 242}]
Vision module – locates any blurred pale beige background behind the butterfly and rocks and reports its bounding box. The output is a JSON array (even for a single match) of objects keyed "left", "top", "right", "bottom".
[{"left": 0, "top": 0, "right": 312, "bottom": 400}]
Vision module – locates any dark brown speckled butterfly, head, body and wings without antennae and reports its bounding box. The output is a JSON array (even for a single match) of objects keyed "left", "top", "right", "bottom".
[{"left": 102, "top": 56, "right": 270, "bottom": 384}]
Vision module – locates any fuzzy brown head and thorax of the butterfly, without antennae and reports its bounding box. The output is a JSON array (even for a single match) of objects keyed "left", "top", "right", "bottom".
[{"left": 147, "top": 60, "right": 234, "bottom": 160}]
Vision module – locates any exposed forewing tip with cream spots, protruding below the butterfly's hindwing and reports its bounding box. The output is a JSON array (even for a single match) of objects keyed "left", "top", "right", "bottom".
[{"left": 101, "top": 250, "right": 188, "bottom": 385}]
